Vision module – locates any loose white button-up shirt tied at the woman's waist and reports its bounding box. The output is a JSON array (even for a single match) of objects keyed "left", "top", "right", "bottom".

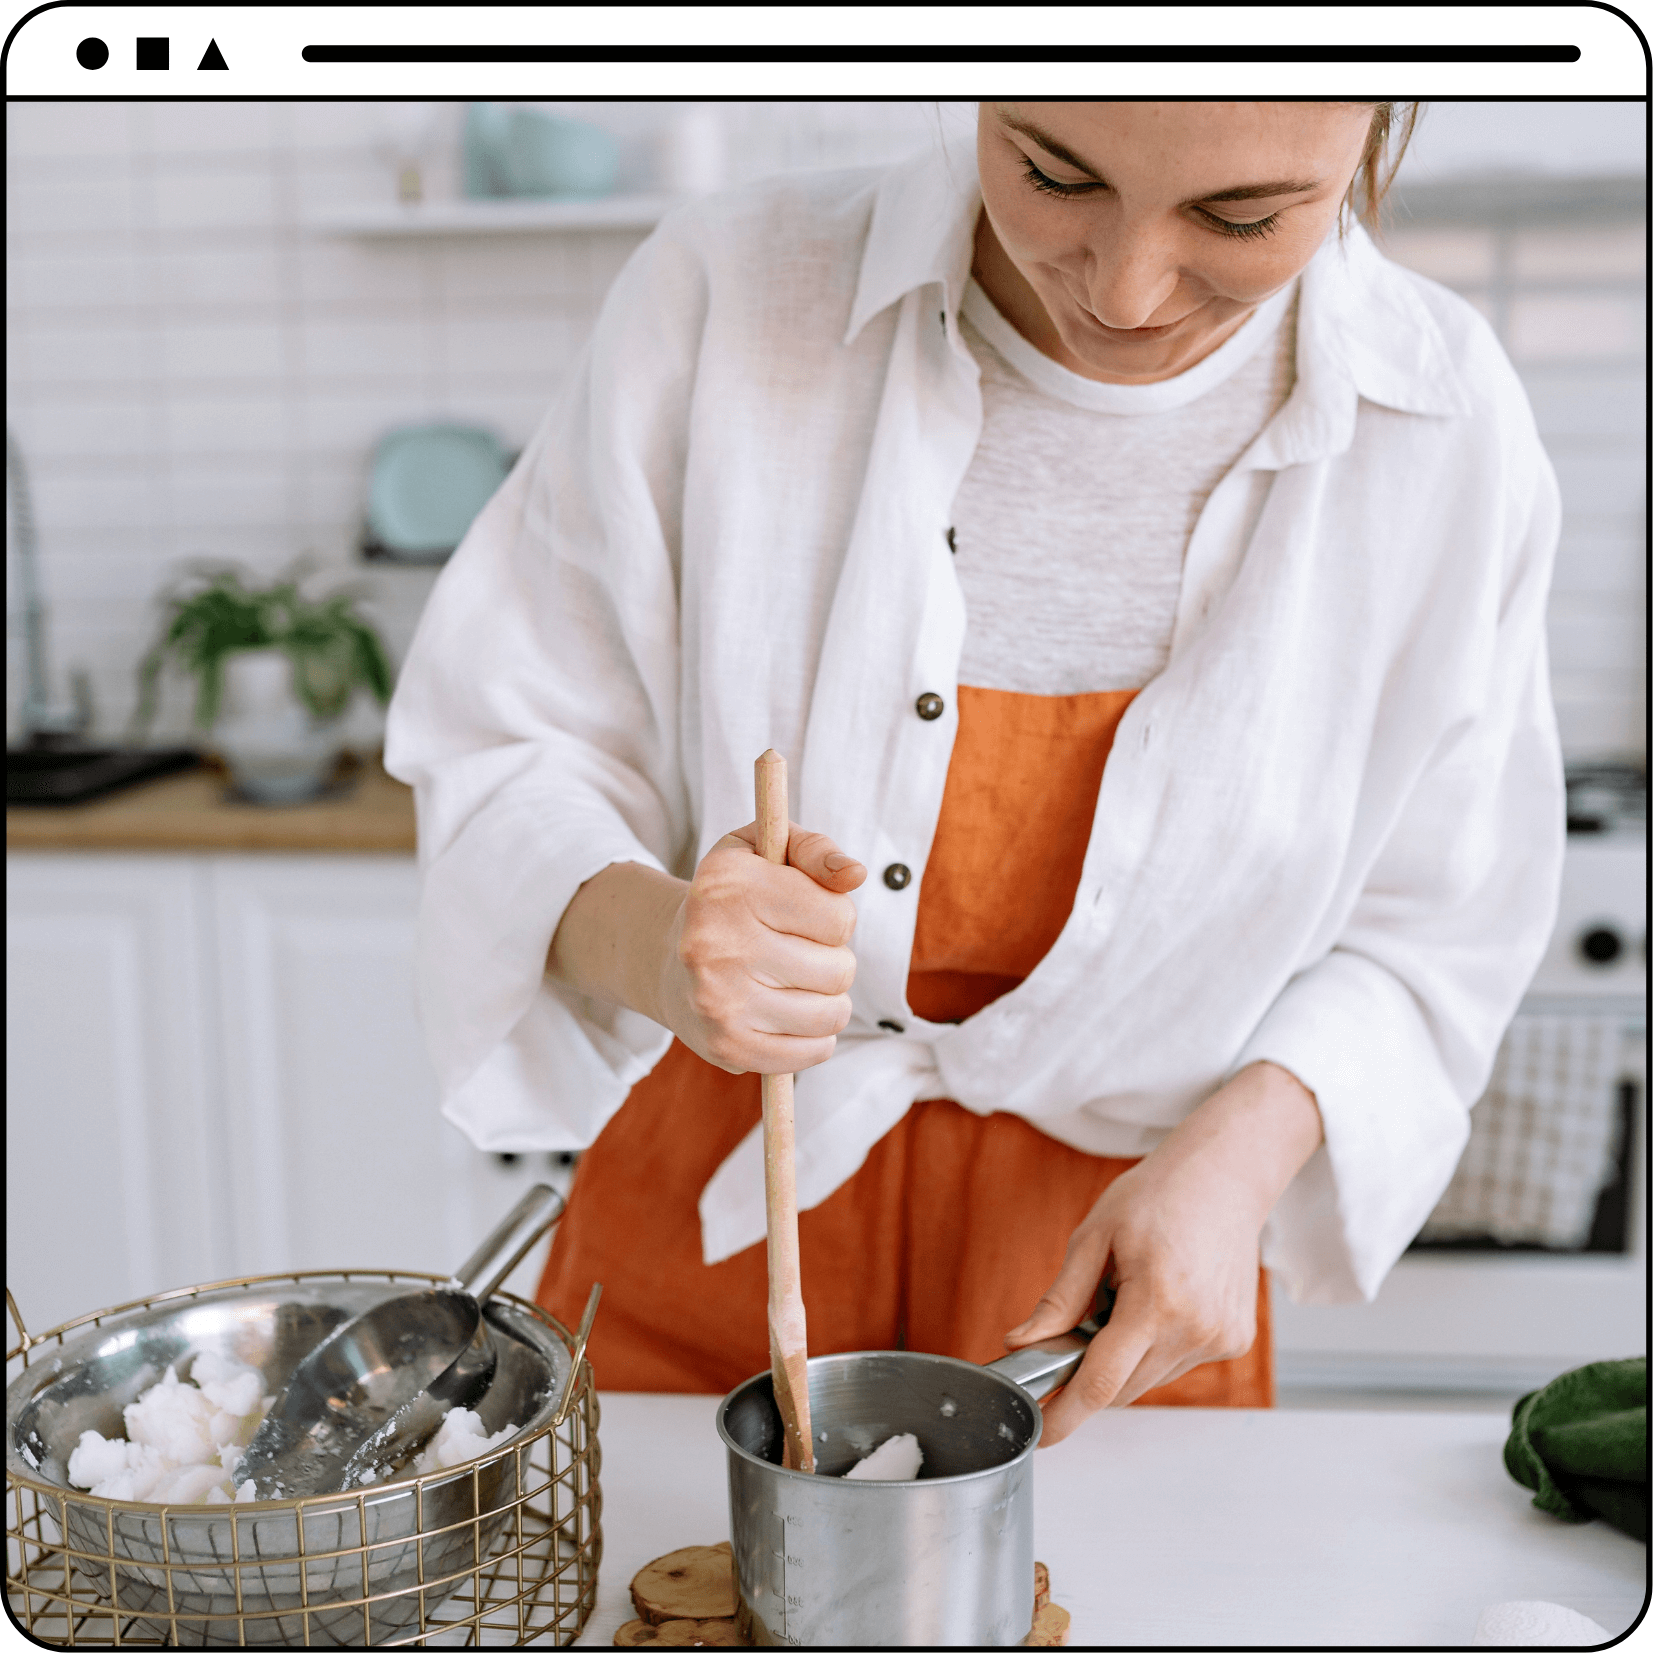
[{"left": 387, "top": 135, "right": 1563, "bottom": 1302}]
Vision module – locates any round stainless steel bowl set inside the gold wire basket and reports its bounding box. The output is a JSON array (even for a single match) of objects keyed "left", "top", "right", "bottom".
[{"left": 5, "top": 1275, "right": 595, "bottom": 1647}]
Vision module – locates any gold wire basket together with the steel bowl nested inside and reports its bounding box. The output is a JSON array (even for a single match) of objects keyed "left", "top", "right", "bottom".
[{"left": 5, "top": 1270, "right": 602, "bottom": 1647}]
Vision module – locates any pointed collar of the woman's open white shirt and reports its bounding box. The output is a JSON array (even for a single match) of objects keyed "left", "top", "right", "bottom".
[{"left": 845, "top": 132, "right": 1470, "bottom": 470}]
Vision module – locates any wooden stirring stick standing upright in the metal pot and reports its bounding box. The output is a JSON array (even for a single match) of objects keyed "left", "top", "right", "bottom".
[{"left": 754, "top": 748, "right": 815, "bottom": 1475}]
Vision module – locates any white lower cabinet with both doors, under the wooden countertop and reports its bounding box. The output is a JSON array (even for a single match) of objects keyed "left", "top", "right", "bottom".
[{"left": 7, "top": 852, "right": 567, "bottom": 1331}]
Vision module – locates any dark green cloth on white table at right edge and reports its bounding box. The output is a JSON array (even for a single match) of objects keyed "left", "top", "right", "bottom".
[{"left": 1505, "top": 1356, "right": 1649, "bottom": 1543}]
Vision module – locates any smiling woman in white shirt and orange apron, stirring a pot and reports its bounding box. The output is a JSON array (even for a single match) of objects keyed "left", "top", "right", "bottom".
[{"left": 389, "top": 103, "right": 1563, "bottom": 1441}]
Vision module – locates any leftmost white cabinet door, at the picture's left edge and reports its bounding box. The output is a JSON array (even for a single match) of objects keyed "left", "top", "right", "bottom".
[{"left": 7, "top": 852, "right": 230, "bottom": 1331}]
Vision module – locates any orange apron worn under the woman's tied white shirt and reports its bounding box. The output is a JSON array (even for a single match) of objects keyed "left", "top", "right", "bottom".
[{"left": 539, "top": 686, "right": 1274, "bottom": 1408}]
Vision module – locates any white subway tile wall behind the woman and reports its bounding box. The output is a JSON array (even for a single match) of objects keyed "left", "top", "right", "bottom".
[{"left": 7, "top": 103, "right": 1646, "bottom": 758}]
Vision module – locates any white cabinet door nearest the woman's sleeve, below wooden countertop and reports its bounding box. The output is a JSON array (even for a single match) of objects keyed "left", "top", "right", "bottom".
[{"left": 210, "top": 855, "right": 488, "bottom": 1274}]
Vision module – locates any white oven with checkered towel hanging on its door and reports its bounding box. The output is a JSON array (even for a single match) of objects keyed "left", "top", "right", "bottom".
[{"left": 1272, "top": 764, "right": 1647, "bottom": 1396}]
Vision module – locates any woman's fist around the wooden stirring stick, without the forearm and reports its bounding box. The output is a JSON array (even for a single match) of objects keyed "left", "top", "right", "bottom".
[{"left": 660, "top": 822, "right": 867, "bottom": 1073}]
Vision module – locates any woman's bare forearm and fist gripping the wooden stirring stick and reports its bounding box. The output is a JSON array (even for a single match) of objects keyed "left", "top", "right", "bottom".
[{"left": 546, "top": 822, "right": 867, "bottom": 1073}]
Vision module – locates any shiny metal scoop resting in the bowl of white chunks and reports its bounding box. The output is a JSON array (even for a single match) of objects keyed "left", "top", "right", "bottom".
[{"left": 235, "top": 1183, "right": 562, "bottom": 1499}]
